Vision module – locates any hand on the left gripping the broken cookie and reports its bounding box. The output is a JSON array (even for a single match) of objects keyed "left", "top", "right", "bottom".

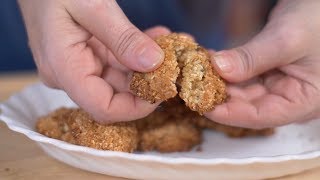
[{"left": 19, "top": 0, "right": 169, "bottom": 122}]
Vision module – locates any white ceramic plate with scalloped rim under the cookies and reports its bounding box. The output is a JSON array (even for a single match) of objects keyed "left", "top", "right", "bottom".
[{"left": 0, "top": 83, "right": 320, "bottom": 179}]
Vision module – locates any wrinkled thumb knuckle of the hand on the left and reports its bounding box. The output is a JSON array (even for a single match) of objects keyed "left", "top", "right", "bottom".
[{"left": 115, "top": 26, "right": 142, "bottom": 56}]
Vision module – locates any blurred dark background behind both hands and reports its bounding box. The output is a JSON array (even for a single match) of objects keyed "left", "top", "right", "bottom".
[{"left": 0, "top": 0, "right": 276, "bottom": 73}]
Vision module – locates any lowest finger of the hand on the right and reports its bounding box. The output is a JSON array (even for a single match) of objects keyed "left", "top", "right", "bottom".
[{"left": 206, "top": 94, "right": 303, "bottom": 129}]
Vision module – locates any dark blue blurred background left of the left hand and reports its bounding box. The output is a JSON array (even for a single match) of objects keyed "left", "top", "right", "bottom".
[{"left": 0, "top": 0, "right": 35, "bottom": 72}]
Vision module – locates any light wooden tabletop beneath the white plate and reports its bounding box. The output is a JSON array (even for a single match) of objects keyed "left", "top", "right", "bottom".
[{"left": 0, "top": 72, "right": 320, "bottom": 180}]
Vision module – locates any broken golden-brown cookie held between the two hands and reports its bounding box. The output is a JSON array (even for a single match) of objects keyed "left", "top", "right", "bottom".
[{"left": 130, "top": 33, "right": 226, "bottom": 114}]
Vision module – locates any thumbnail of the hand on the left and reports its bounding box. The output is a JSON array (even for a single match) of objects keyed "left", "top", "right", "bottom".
[{"left": 138, "top": 47, "right": 164, "bottom": 70}]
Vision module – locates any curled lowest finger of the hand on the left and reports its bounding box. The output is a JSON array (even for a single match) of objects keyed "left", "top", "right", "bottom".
[{"left": 56, "top": 47, "right": 157, "bottom": 123}]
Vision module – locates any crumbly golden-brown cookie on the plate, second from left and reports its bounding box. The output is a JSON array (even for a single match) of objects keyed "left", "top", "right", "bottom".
[{"left": 68, "top": 109, "right": 138, "bottom": 152}]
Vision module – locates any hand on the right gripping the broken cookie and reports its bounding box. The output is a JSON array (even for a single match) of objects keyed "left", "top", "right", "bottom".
[{"left": 206, "top": 0, "right": 320, "bottom": 128}]
